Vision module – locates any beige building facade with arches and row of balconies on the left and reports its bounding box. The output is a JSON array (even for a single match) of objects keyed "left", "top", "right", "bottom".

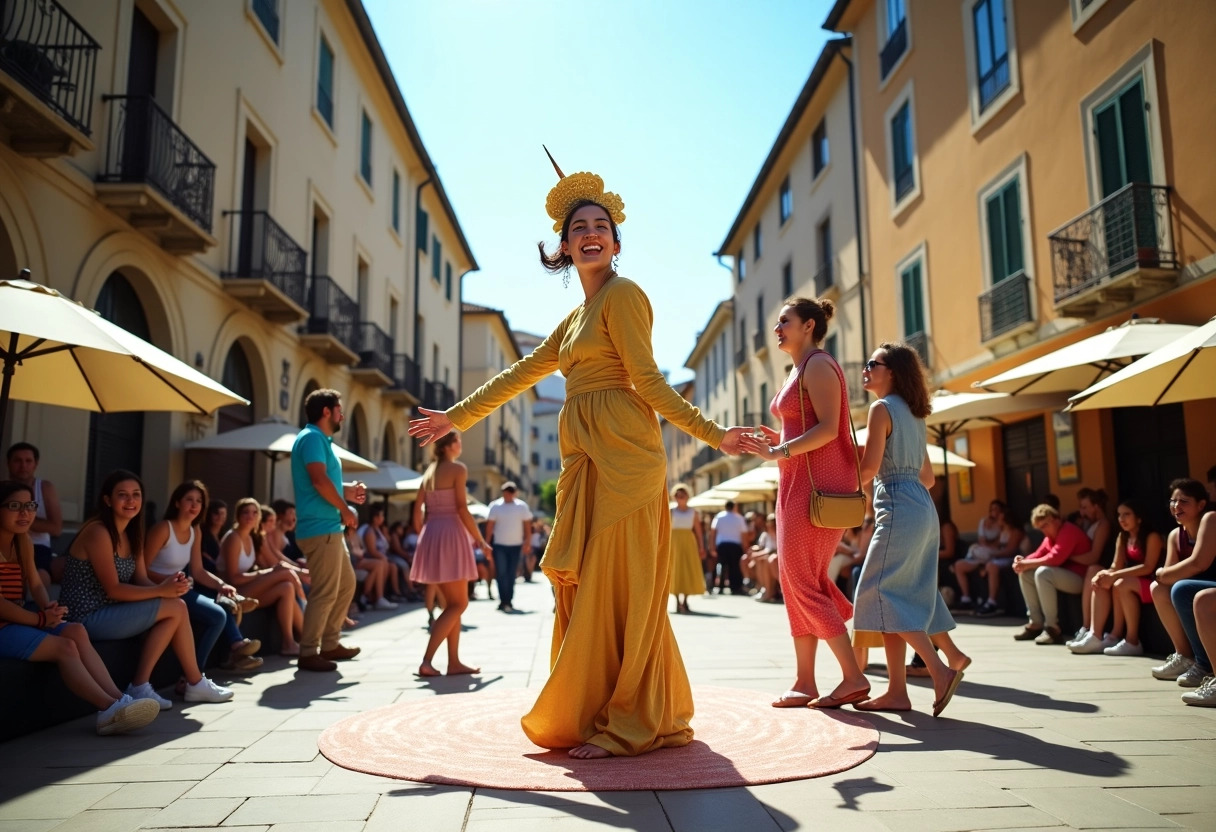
[{"left": 0, "top": 0, "right": 477, "bottom": 522}]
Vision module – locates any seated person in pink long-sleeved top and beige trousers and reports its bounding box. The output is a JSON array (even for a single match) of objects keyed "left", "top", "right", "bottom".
[{"left": 1013, "top": 504, "right": 1090, "bottom": 645}]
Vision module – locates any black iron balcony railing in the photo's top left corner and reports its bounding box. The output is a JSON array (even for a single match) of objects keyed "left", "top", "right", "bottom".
[{"left": 0, "top": 0, "right": 101, "bottom": 136}]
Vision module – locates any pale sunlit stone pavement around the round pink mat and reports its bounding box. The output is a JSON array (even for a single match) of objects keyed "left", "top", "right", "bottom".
[{"left": 0, "top": 583, "right": 1216, "bottom": 832}]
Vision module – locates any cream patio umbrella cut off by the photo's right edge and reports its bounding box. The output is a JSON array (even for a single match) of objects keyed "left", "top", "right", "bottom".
[{"left": 1069, "top": 317, "right": 1216, "bottom": 410}]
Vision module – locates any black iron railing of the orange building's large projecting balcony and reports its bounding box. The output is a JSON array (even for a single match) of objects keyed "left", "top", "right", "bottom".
[{"left": 1047, "top": 182, "right": 1178, "bottom": 305}]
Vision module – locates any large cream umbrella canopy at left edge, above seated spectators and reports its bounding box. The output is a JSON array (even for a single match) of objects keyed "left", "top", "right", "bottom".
[{"left": 0, "top": 269, "right": 249, "bottom": 431}]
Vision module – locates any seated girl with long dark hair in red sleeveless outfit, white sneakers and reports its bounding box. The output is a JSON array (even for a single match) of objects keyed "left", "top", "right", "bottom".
[{"left": 1068, "top": 500, "right": 1164, "bottom": 656}]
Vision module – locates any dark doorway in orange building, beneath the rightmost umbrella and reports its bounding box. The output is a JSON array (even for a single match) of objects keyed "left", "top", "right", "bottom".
[{"left": 1110, "top": 404, "right": 1190, "bottom": 534}]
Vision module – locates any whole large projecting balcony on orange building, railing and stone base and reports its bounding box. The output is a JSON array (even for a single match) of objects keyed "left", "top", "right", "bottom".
[{"left": 1047, "top": 182, "right": 1180, "bottom": 317}]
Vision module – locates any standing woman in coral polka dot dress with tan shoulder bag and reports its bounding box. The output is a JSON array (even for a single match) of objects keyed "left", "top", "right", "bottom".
[{"left": 759, "top": 298, "right": 869, "bottom": 708}]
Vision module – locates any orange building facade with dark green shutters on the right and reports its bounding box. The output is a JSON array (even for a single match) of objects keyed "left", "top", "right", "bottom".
[{"left": 824, "top": 0, "right": 1216, "bottom": 528}]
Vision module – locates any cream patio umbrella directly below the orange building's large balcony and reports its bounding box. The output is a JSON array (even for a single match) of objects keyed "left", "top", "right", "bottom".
[{"left": 973, "top": 317, "right": 1198, "bottom": 395}]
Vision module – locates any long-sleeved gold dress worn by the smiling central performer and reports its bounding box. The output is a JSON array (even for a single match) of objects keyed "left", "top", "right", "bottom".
[{"left": 447, "top": 276, "right": 725, "bottom": 757}]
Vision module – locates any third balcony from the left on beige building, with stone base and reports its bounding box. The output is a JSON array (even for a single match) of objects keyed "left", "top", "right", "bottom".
[{"left": 220, "top": 210, "right": 309, "bottom": 324}]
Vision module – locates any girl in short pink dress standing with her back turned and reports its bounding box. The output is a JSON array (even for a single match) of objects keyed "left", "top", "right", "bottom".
[{"left": 410, "top": 431, "right": 490, "bottom": 676}]
